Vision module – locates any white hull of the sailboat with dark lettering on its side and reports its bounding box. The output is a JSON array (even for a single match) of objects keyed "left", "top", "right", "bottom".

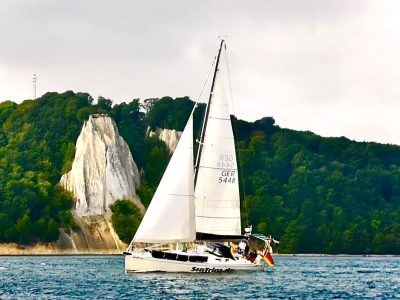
[{"left": 125, "top": 253, "right": 264, "bottom": 273}]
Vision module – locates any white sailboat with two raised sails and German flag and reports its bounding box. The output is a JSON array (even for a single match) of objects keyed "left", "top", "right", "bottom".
[{"left": 124, "top": 40, "right": 272, "bottom": 273}]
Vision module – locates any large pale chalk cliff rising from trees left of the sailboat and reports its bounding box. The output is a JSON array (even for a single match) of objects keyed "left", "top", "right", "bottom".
[{"left": 60, "top": 115, "right": 143, "bottom": 217}]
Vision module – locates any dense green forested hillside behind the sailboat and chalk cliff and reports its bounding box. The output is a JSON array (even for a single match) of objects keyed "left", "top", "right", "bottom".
[{"left": 0, "top": 91, "right": 400, "bottom": 254}]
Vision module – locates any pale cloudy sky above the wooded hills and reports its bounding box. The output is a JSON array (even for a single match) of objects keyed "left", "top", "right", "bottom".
[{"left": 0, "top": 0, "right": 400, "bottom": 145}]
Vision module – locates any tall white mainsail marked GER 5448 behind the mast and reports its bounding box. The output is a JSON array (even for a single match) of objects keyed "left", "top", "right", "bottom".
[{"left": 195, "top": 63, "right": 241, "bottom": 235}]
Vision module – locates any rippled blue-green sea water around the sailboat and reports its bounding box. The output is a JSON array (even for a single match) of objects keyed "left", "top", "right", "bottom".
[{"left": 0, "top": 256, "right": 400, "bottom": 299}]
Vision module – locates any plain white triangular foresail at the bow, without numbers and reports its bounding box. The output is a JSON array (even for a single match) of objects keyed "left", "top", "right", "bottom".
[{"left": 132, "top": 116, "right": 196, "bottom": 243}]
